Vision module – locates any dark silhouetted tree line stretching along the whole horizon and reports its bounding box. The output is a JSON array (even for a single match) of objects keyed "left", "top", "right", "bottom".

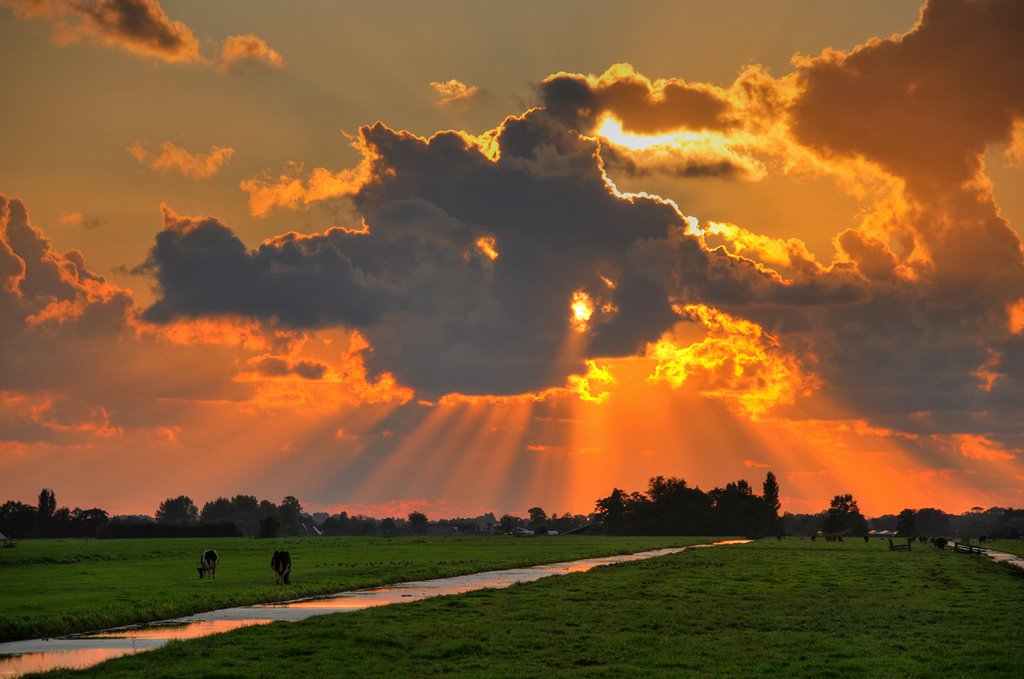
[{"left": 0, "top": 471, "right": 1024, "bottom": 539}]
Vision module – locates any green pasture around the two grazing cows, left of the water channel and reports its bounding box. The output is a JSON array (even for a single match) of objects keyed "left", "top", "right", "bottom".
[{"left": 0, "top": 536, "right": 710, "bottom": 641}]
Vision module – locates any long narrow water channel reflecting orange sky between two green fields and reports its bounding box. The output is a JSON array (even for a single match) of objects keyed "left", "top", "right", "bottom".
[{"left": 0, "top": 540, "right": 751, "bottom": 677}]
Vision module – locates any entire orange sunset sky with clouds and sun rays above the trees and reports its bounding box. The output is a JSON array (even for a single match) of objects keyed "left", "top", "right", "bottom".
[{"left": 0, "top": 0, "right": 1024, "bottom": 518}]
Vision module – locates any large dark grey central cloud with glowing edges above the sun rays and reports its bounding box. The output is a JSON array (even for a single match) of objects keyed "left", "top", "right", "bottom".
[{"left": 145, "top": 110, "right": 855, "bottom": 395}]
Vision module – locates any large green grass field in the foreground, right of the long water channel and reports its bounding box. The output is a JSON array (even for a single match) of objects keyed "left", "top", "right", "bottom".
[{"left": 37, "top": 539, "right": 1024, "bottom": 677}]
